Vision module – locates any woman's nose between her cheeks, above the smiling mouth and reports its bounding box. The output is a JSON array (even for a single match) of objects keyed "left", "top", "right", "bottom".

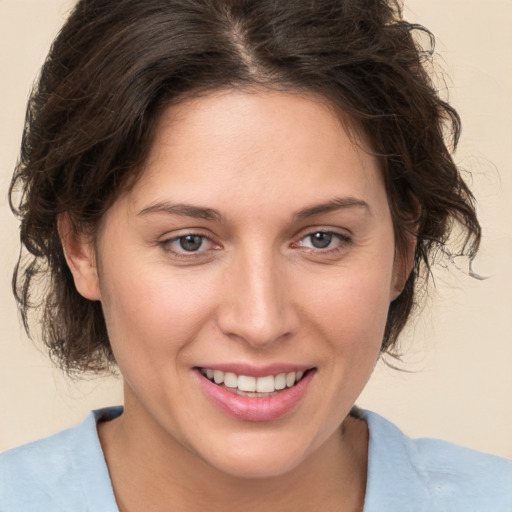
[{"left": 217, "top": 247, "right": 299, "bottom": 348}]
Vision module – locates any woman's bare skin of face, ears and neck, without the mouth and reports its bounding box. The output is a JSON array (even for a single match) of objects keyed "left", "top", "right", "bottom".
[{"left": 60, "top": 90, "right": 408, "bottom": 511}]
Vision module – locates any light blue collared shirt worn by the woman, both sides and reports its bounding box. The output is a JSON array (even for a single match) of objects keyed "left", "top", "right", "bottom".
[{"left": 0, "top": 407, "right": 512, "bottom": 512}]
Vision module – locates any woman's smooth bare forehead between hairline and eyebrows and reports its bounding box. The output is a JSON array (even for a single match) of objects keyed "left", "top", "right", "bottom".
[{"left": 125, "top": 90, "right": 384, "bottom": 220}]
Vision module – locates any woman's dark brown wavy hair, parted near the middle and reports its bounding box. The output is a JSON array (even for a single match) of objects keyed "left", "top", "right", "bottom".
[{"left": 10, "top": 0, "right": 480, "bottom": 373}]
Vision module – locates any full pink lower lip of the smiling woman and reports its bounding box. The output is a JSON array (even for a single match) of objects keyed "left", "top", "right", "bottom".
[{"left": 196, "top": 370, "right": 315, "bottom": 421}]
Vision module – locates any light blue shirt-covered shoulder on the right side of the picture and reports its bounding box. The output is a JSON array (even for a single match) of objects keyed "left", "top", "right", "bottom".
[{"left": 361, "top": 411, "right": 512, "bottom": 512}]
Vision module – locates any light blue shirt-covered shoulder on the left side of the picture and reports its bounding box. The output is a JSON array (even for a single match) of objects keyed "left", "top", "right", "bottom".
[{"left": 0, "top": 408, "right": 122, "bottom": 512}]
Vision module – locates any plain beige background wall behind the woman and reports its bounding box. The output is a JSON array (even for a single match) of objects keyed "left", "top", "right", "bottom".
[{"left": 0, "top": 0, "right": 512, "bottom": 457}]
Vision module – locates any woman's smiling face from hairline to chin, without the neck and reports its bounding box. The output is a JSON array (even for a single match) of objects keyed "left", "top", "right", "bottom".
[{"left": 75, "top": 87, "right": 403, "bottom": 477}]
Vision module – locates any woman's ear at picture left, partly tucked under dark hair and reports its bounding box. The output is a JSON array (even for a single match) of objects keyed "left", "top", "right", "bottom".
[{"left": 57, "top": 213, "right": 101, "bottom": 300}]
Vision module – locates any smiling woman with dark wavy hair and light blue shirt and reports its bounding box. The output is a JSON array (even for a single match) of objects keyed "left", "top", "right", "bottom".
[{"left": 0, "top": 0, "right": 512, "bottom": 512}]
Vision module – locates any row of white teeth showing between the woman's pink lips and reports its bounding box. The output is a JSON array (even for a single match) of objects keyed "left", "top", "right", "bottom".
[{"left": 199, "top": 368, "right": 313, "bottom": 398}]
